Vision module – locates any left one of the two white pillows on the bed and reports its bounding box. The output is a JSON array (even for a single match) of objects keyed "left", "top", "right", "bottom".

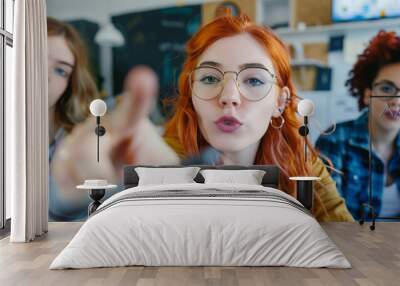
[{"left": 135, "top": 167, "right": 200, "bottom": 186}]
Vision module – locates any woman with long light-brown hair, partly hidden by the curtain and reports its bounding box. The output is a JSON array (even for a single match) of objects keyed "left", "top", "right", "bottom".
[{"left": 47, "top": 18, "right": 99, "bottom": 220}]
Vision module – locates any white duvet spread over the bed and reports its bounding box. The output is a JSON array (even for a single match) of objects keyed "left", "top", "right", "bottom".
[{"left": 50, "top": 184, "right": 351, "bottom": 269}]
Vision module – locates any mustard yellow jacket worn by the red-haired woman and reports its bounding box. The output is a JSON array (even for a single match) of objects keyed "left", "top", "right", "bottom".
[{"left": 164, "top": 138, "right": 354, "bottom": 222}]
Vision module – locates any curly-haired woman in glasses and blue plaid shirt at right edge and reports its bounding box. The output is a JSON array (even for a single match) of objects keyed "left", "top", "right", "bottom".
[{"left": 316, "top": 31, "right": 400, "bottom": 218}]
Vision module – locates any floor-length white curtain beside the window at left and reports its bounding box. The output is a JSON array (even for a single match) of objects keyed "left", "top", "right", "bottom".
[{"left": 6, "top": 0, "right": 49, "bottom": 242}]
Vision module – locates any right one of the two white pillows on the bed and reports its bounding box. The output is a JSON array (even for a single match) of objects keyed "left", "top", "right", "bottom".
[{"left": 200, "top": 169, "right": 265, "bottom": 185}]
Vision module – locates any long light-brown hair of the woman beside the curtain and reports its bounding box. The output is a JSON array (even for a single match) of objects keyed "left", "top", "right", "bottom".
[{"left": 47, "top": 17, "right": 100, "bottom": 132}]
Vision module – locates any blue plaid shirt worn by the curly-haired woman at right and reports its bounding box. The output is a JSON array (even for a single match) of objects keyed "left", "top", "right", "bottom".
[{"left": 316, "top": 111, "right": 400, "bottom": 219}]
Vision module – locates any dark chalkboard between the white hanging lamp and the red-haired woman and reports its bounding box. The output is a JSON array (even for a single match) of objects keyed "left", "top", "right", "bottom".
[{"left": 112, "top": 5, "right": 201, "bottom": 116}]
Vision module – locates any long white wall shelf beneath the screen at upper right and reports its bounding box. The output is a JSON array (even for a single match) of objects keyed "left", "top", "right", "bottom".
[{"left": 274, "top": 18, "right": 400, "bottom": 42}]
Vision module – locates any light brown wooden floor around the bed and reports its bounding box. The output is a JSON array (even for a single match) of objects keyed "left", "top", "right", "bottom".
[{"left": 0, "top": 222, "right": 400, "bottom": 286}]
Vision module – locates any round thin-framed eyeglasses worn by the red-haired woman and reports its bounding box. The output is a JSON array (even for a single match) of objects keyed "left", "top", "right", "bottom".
[{"left": 189, "top": 66, "right": 276, "bottom": 101}]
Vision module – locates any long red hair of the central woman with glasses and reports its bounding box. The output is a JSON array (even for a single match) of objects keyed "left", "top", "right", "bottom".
[{"left": 165, "top": 15, "right": 316, "bottom": 195}]
